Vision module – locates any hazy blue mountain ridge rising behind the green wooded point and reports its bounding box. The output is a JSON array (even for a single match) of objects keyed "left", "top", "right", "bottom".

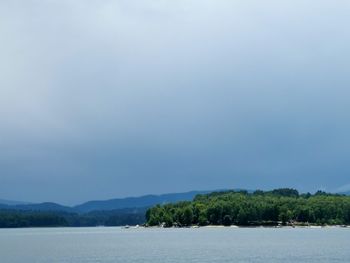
[{"left": 73, "top": 191, "right": 212, "bottom": 213}]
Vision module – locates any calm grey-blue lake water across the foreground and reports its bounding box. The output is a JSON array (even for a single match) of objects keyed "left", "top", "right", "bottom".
[{"left": 0, "top": 227, "right": 350, "bottom": 263}]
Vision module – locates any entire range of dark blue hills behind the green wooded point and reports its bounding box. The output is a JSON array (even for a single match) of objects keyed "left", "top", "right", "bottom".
[{"left": 0, "top": 191, "right": 208, "bottom": 228}]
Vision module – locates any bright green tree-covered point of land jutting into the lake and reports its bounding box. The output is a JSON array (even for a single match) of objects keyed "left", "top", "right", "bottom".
[{"left": 146, "top": 188, "right": 350, "bottom": 227}]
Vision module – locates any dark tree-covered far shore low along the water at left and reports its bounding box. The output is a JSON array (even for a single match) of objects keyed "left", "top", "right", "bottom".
[{"left": 0, "top": 208, "right": 146, "bottom": 228}]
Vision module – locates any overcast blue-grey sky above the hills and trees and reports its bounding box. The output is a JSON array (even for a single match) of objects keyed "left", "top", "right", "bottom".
[{"left": 0, "top": 0, "right": 350, "bottom": 205}]
